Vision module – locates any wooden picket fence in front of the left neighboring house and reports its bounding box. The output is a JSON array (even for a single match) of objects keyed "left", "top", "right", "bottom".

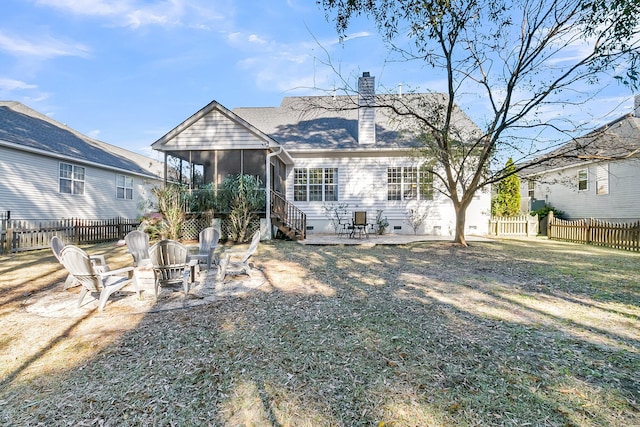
[{"left": 0, "top": 218, "right": 140, "bottom": 253}]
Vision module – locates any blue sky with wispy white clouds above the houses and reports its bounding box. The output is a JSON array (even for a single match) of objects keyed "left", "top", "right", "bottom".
[{"left": 0, "top": 0, "right": 633, "bottom": 160}]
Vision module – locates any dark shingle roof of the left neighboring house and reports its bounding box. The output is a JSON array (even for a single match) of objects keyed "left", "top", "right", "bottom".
[{"left": 0, "top": 101, "right": 162, "bottom": 177}]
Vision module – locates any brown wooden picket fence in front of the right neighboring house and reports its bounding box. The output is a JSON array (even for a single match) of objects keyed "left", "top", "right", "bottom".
[{"left": 547, "top": 212, "right": 640, "bottom": 252}]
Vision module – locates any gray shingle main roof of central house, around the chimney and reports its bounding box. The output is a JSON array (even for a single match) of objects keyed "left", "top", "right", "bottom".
[{"left": 233, "top": 94, "right": 478, "bottom": 151}]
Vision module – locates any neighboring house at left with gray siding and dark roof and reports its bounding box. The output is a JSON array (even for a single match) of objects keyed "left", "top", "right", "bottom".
[{"left": 0, "top": 101, "right": 163, "bottom": 220}]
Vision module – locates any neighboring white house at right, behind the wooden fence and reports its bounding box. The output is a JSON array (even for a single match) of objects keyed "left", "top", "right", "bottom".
[{"left": 520, "top": 104, "right": 640, "bottom": 222}]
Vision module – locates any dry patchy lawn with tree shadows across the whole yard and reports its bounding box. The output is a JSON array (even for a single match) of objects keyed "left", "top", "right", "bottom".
[{"left": 0, "top": 239, "right": 640, "bottom": 426}]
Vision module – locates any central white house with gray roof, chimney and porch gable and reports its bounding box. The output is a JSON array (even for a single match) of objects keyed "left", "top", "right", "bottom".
[{"left": 152, "top": 73, "right": 490, "bottom": 238}]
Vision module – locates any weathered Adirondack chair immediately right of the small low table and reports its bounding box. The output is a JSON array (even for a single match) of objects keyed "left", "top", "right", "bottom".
[{"left": 149, "top": 240, "right": 192, "bottom": 298}]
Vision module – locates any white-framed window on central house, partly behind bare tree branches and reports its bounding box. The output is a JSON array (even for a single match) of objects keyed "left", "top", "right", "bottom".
[{"left": 387, "top": 166, "right": 433, "bottom": 200}]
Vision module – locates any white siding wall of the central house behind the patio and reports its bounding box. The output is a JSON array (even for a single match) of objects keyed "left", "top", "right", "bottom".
[{"left": 286, "top": 153, "right": 490, "bottom": 236}]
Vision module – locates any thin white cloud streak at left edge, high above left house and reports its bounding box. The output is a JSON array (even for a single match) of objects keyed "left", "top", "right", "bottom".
[{"left": 0, "top": 31, "right": 89, "bottom": 58}]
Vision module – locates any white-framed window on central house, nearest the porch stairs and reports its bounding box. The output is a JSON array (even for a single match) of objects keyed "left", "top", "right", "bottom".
[{"left": 293, "top": 168, "right": 338, "bottom": 202}]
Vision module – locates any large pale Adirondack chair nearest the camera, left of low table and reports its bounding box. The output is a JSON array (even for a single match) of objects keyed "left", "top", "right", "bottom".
[{"left": 60, "top": 245, "right": 140, "bottom": 311}]
